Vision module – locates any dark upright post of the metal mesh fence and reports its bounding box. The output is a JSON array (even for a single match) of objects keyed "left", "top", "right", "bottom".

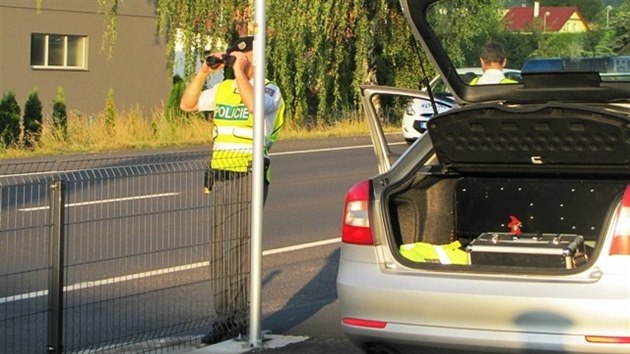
[{"left": 46, "top": 180, "right": 66, "bottom": 353}]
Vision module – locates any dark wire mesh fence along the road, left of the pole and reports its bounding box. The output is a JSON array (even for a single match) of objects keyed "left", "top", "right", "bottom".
[{"left": 0, "top": 151, "right": 250, "bottom": 353}]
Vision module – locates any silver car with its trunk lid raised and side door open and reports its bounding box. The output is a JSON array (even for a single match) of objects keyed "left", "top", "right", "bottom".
[{"left": 337, "top": 0, "right": 630, "bottom": 354}]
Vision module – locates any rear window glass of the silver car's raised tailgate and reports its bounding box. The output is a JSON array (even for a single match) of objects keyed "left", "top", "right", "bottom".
[{"left": 427, "top": 0, "right": 630, "bottom": 84}]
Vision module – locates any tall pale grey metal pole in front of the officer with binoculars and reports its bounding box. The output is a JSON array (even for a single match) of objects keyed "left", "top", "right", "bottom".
[{"left": 249, "top": 0, "right": 266, "bottom": 347}]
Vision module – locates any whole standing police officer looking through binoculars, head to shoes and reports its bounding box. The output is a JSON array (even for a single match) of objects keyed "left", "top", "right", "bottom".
[{"left": 180, "top": 37, "right": 284, "bottom": 344}]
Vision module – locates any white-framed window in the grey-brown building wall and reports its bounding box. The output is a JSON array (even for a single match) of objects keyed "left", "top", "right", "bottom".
[{"left": 31, "top": 33, "right": 88, "bottom": 70}]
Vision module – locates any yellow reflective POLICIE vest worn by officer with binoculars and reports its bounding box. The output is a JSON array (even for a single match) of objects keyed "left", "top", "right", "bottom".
[{"left": 210, "top": 80, "right": 284, "bottom": 180}]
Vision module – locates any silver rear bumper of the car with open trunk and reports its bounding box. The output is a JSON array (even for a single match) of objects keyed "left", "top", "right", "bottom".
[{"left": 337, "top": 245, "right": 630, "bottom": 353}]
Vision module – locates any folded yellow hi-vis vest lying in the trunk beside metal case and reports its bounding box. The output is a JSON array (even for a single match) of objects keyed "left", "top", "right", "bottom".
[{"left": 400, "top": 241, "right": 468, "bottom": 265}]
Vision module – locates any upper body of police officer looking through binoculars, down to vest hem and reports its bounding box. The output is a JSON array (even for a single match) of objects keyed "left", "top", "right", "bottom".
[{"left": 180, "top": 36, "right": 284, "bottom": 196}]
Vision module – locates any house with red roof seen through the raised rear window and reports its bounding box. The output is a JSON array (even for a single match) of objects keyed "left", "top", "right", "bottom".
[{"left": 501, "top": 5, "right": 589, "bottom": 32}]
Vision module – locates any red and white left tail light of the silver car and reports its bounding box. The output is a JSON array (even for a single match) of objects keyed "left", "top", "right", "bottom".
[{"left": 341, "top": 180, "right": 374, "bottom": 245}]
